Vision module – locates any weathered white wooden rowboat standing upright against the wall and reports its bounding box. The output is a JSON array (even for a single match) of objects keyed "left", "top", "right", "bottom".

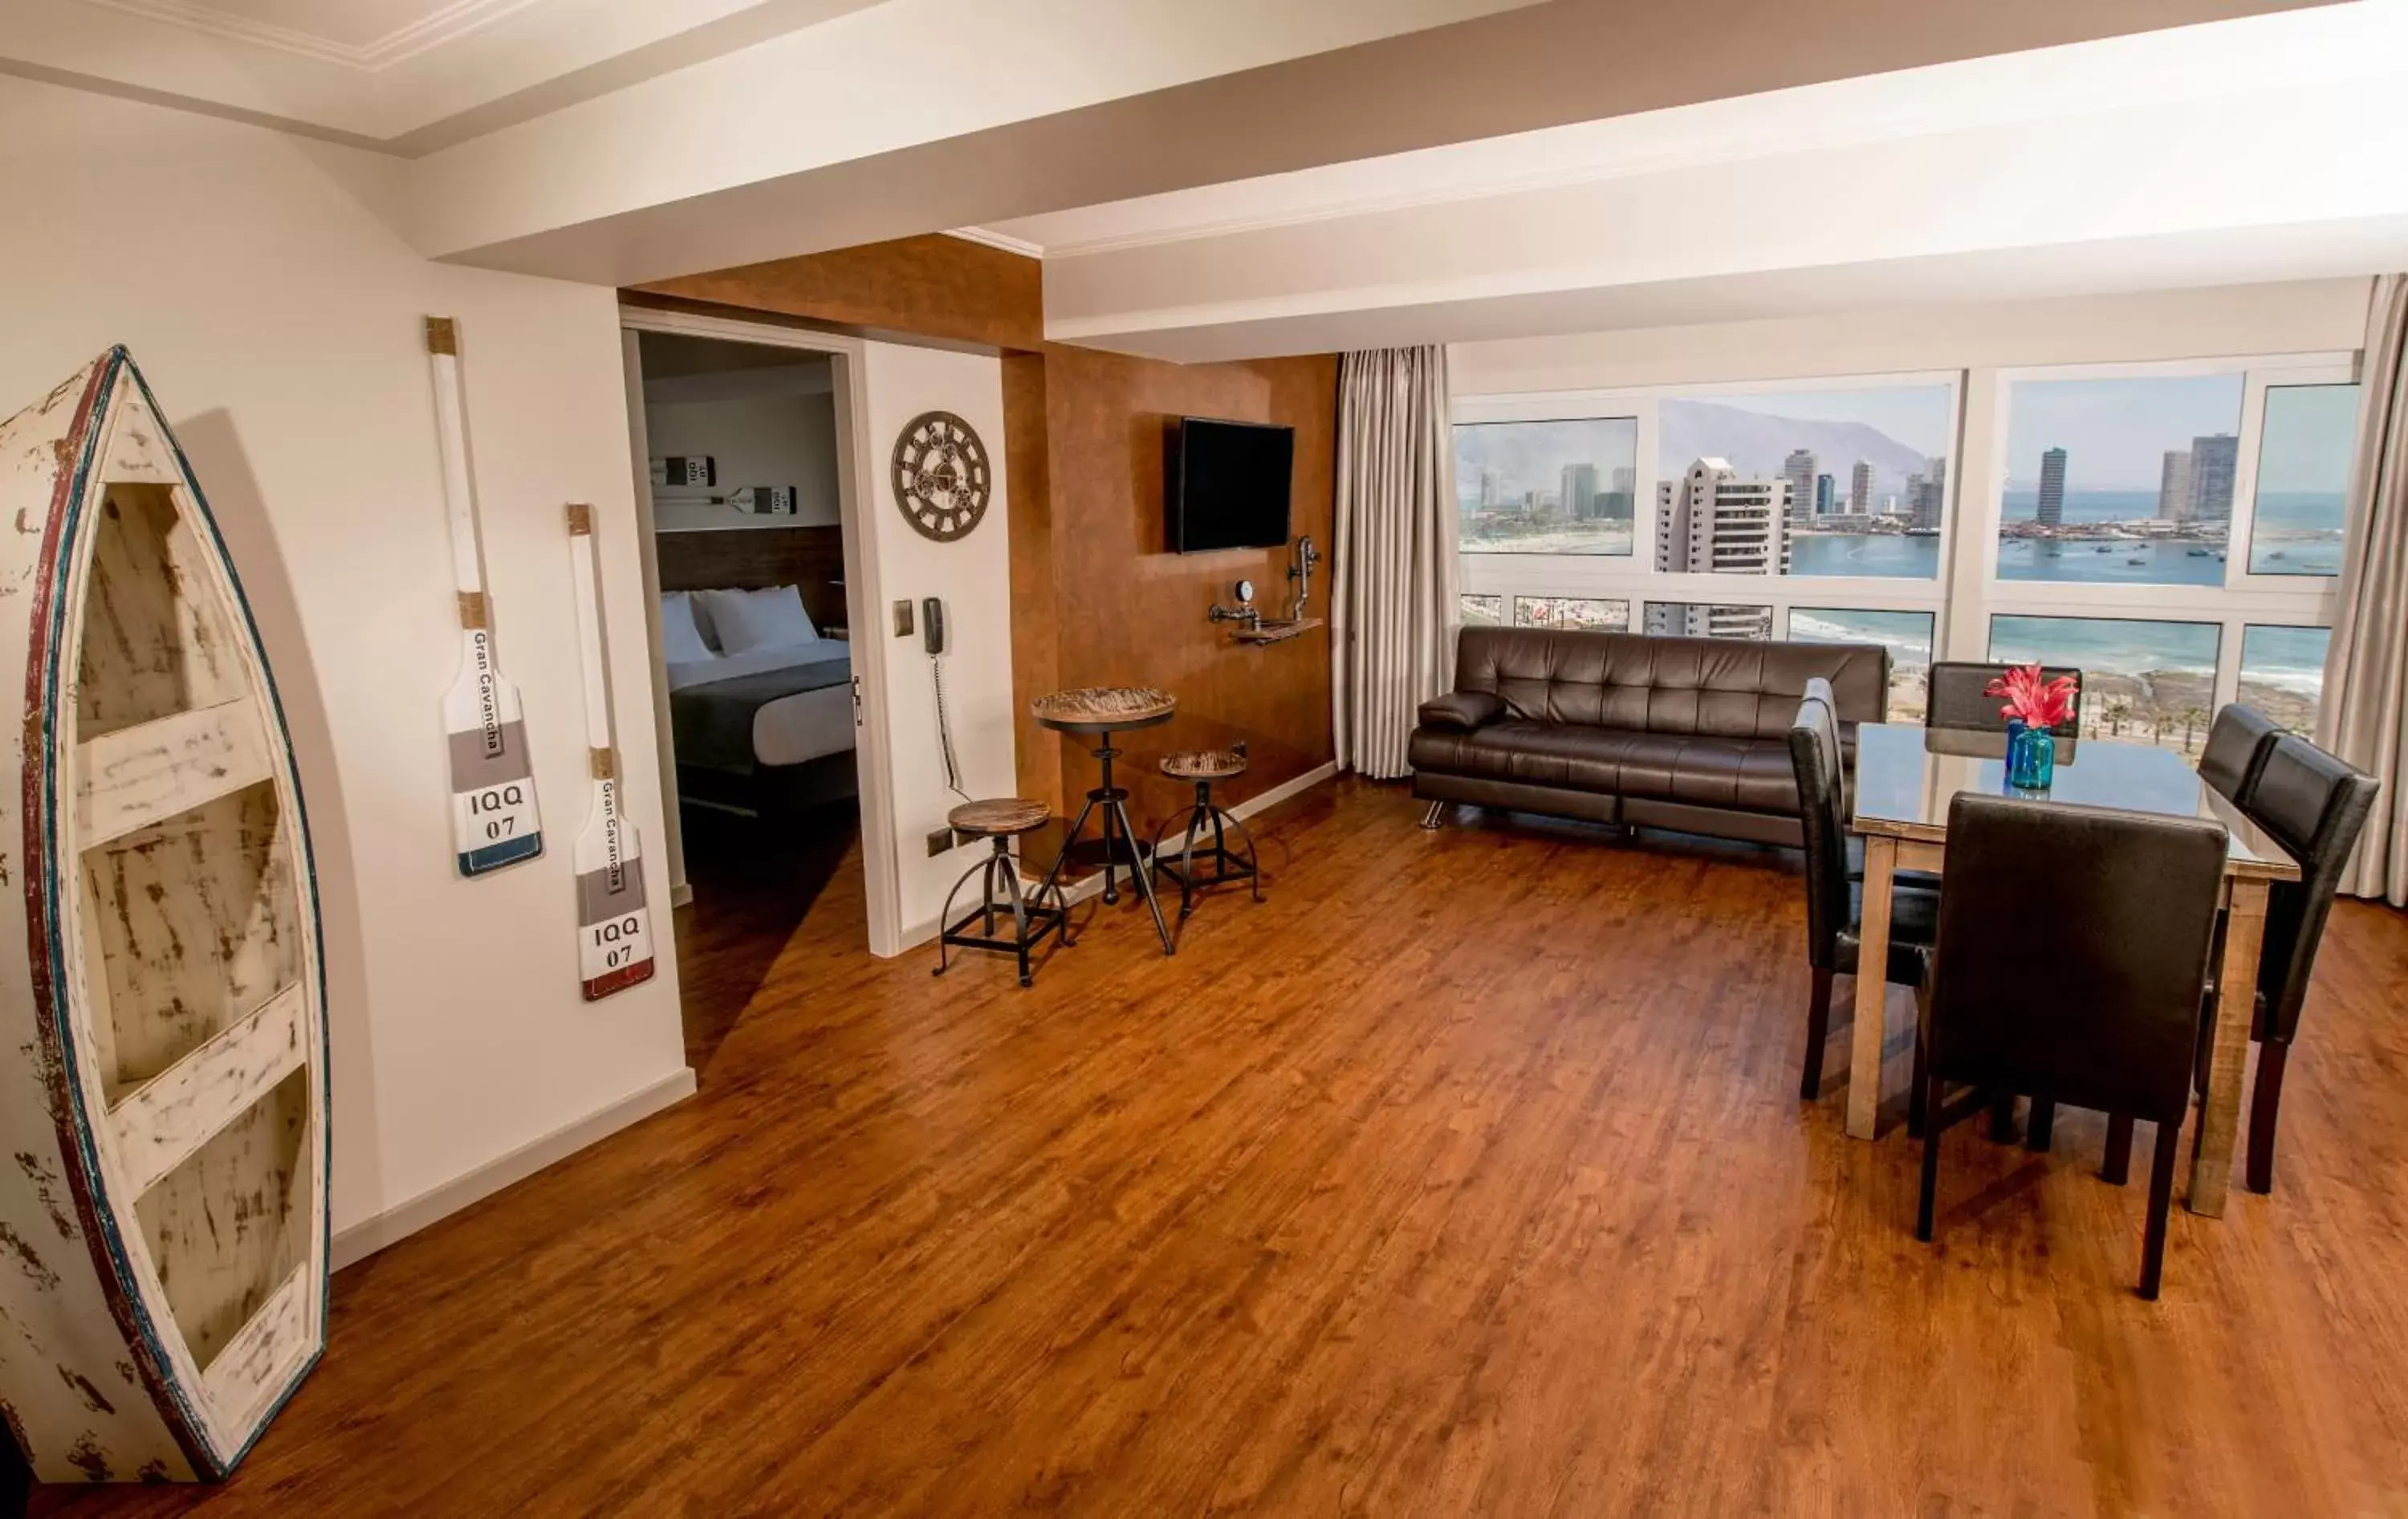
[{"left": 0, "top": 349, "right": 327, "bottom": 1483}]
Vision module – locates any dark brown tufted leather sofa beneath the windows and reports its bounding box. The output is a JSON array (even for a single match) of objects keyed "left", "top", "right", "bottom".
[{"left": 1406, "top": 629, "right": 1890, "bottom": 845}]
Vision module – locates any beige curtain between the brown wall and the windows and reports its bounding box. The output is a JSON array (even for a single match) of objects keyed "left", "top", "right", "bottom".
[{"left": 1329, "top": 344, "right": 1459, "bottom": 780}]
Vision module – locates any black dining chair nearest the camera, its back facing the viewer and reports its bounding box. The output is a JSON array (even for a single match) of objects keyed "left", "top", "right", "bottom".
[{"left": 1914, "top": 792, "right": 2225, "bottom": 1297}]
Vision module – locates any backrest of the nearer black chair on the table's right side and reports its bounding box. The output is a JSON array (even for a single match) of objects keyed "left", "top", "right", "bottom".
[{"left": 2225, "top": 736, "right": 2374, "bottom": 1045}]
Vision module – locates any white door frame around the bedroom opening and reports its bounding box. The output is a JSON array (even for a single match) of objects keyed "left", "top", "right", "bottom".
[{"left": 619, "top": 306, "right": 903, "bottom": 955}]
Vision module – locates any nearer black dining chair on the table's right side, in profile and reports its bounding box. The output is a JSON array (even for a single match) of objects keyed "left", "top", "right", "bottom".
[{"left": 2218, "top": 735, "right": 2377, "bottom": 1191}]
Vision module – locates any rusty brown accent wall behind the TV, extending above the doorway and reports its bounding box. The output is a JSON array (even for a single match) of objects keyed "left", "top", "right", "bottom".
[{"left": 643, "top": 236, "right": 1336, "bottom": 821}]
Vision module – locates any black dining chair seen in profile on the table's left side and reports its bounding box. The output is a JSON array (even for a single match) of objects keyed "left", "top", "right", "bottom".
[{"left": 1789, "top": 679, "right": 1936, "bottom": 1102}]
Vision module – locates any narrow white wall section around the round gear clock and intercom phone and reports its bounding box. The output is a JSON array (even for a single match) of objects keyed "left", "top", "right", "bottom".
[{"left": 852, "top": 342, "right": 1016, "bottom": 943}]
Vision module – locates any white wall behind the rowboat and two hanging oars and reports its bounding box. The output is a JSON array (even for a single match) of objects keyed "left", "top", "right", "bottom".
[{"left": 0, "top": 77, "right": 698, "bottom": 1232}]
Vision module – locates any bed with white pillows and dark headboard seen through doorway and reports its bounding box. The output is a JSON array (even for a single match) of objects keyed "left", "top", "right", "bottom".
[{"left": 655, "top": 527, "right": 857, "bottom": 816}]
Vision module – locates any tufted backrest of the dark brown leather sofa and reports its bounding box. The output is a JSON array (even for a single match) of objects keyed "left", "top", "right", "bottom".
[{"left": 1454, "top": 629, "right": 1890, "bottom": 739}]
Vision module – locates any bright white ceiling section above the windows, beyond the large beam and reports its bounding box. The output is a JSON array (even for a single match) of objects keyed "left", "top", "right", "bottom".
[{"left": 966, "top": 0, "right": 2408, "bottom": 361}]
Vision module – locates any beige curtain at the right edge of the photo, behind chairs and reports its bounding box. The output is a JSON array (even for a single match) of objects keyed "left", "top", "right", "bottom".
[{"left": 2316, "top": 275, "right": 2408, "bottom": 907}]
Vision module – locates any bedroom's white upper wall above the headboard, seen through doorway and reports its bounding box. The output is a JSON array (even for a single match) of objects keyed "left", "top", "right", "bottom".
[{"left": 643, "top": 393, "right": 836, "bottom": 532}]
